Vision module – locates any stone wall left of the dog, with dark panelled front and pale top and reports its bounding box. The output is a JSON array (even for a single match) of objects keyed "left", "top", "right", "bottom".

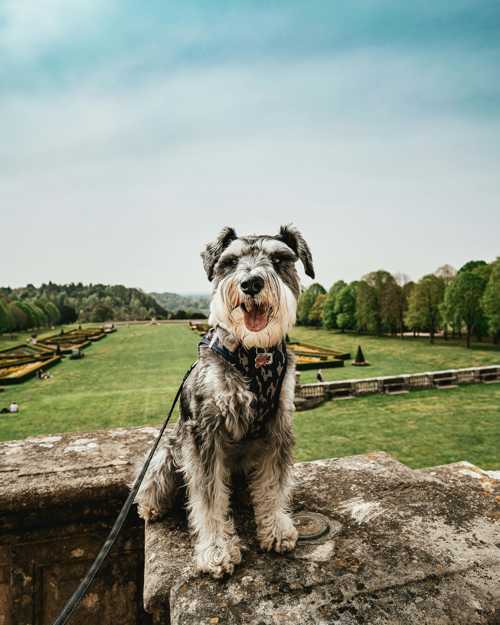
[{"left": 0, "top": 428, "right": 157, "bottom": 625}]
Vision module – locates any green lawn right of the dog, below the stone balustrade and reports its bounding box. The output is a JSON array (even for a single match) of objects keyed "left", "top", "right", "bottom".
[{"left": 295, "top": 384, "right": 500, "bottom": 469}]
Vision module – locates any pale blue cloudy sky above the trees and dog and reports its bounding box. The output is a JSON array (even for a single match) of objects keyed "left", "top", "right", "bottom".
[{"left": 0, "top": 0, "right": 500, "bottom": 293}]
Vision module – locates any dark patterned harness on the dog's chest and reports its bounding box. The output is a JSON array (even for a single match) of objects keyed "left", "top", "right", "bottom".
[{"left": 199, "top": 329, "right": 288, "bottom": 438}]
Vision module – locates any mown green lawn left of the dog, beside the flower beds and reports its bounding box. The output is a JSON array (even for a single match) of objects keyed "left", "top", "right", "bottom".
[{"left": 0, "top": 324, "right": 198, "bottom": 440}]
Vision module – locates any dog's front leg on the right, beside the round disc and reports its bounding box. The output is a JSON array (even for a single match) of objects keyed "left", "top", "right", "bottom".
[{"left": 249, "top": 432, "right": 298, "bottom": 553}]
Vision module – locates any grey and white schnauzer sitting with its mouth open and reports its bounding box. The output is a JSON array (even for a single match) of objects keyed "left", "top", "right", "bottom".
[{"left": 137, "top": 226, "right": 314, "bottom": 578}]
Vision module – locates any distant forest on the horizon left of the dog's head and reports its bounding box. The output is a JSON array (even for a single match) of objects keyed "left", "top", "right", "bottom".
[{"left": 0, "top": 282, "right": 206, "bottom": 332}]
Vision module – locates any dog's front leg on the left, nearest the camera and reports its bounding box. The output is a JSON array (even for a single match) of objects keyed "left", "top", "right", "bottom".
[{"left": 184, "top": 437, "right": 241, "bottom": 578}]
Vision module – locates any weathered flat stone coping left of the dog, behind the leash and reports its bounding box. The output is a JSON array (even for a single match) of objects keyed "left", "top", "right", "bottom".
[{"left": 0, "top": 427, "right": 158, "bottom": 530}]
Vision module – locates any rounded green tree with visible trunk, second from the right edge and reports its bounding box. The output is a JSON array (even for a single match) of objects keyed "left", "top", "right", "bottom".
[{"left": 448, "top": 266, "right": 486, "bottom": 347}]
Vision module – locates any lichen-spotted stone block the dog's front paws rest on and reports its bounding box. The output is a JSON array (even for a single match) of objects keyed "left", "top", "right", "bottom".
[{"left": 144, "top": 453, "right": 500, "bottom": 625}]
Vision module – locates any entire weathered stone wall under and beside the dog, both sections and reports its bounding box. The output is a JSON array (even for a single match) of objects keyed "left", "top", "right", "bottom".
[{"left": 0, "top": 428, "right": 500, "bottom": 625}]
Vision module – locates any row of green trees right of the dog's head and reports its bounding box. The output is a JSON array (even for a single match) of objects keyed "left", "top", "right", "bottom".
[{"left": 297, "top": 257, "right": 500, "bottom": 347}]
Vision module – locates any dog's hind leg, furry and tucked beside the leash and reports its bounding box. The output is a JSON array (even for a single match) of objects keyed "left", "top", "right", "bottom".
[{"left": 136, "top": 440, "right": 178, "bottom": 521}]
